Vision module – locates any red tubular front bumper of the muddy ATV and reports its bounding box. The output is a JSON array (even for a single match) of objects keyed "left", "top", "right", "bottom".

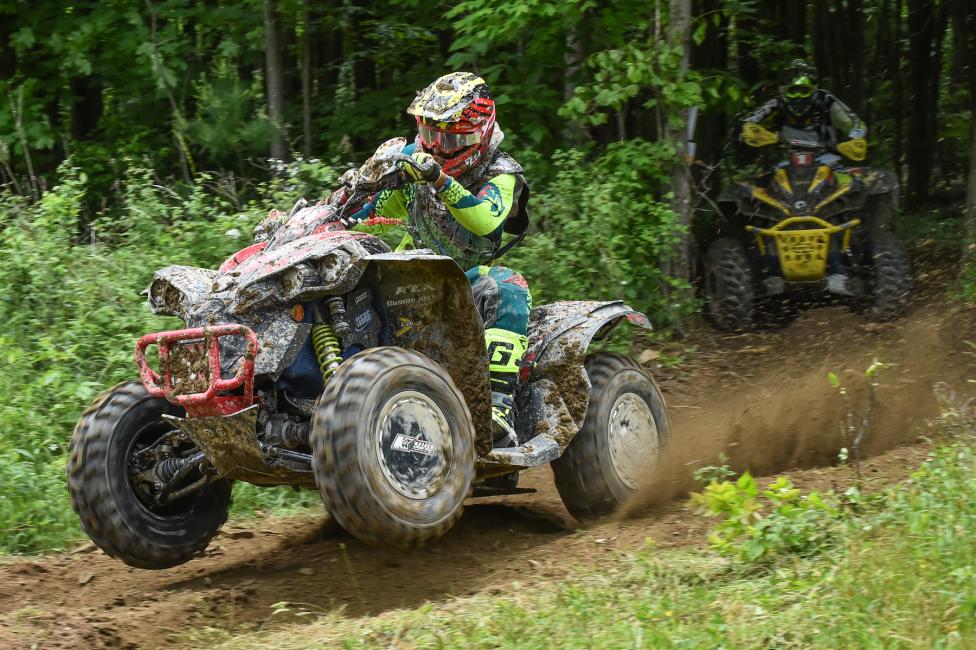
[{"left": 136, "top": 325, "right": 258, "bottom": 417}]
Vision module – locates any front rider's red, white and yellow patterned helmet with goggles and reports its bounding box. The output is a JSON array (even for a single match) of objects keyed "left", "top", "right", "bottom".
[{"left": 407, "top": 72, "right": 495, "bottom": 176}]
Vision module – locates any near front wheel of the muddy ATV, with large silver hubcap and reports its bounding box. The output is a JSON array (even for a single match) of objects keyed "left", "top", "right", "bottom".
[{"left": 311, "top": 347, "right": 475, "bottom": 546}]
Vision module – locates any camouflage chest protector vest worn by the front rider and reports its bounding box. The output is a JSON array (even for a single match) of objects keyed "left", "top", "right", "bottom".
[{"left": 409, "top": 133, "right": 529, "bottom": 269}]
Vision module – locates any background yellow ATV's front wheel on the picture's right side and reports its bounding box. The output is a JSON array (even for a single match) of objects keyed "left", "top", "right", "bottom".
[{"left": 867, "top": 231, "right": 914, "bottom": 321}]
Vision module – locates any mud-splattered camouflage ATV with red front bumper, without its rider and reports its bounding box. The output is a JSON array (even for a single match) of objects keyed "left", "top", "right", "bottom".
[{"left": 68, "top": 138, "right": 670, "bottom": 569}]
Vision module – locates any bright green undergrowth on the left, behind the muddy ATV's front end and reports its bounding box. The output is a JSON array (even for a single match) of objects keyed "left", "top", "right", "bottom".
[{"left": 0, "top": 161, "right": 336, "bottom": 552}]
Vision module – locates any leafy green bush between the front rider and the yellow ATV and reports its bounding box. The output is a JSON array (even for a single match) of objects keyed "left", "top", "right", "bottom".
[{"left": 504, "top": 140, "right": 691, "bottom": 324}]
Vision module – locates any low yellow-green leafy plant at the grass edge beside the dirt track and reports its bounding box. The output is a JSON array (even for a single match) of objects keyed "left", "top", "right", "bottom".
[{"left": 691, "top": 472, "right": 843, "bottom": 564}]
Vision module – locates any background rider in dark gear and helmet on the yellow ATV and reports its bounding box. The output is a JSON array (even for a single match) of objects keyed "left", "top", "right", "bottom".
[{"left": 743, "top": 59, "right": 867, "bottom": 165}]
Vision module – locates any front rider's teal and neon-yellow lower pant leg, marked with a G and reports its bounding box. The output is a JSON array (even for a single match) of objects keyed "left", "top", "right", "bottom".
[{"left": 467, "top": 266, "right": 532, "bottom": 394}]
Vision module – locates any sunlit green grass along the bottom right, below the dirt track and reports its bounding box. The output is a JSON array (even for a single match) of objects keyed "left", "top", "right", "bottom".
[{"left": 204, "top": 442, "right": 976, "bottom": 648}]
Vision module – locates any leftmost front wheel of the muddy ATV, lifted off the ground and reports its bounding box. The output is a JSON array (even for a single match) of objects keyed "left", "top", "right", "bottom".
[{"left": 68, "top": 382, "right": 231, "bottom": 569}]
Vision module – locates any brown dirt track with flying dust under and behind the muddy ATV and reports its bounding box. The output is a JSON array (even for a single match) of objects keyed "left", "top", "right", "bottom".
[{"left": 0, "top": 272, "right": 976, "bottom": 648}]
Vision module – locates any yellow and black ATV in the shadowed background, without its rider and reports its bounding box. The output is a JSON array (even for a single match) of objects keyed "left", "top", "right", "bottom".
[{"left": 705, "top": 123, "right": 913, "bottom": 331}]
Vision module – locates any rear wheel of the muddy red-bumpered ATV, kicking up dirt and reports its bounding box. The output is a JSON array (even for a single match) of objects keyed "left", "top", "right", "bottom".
[{"left": 552, "top": 352, "right": 671, "bottom": 521}]
